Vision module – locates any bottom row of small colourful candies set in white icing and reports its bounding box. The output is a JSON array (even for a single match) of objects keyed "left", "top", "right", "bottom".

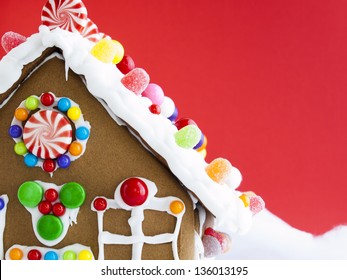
[{"left": 5, "top": 243, "right": 94, "bottom": 260}]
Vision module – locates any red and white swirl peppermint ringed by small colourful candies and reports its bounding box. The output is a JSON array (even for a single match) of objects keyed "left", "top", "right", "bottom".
[{"left": 23, "top": 110, "right": 72, "bottom": 159}]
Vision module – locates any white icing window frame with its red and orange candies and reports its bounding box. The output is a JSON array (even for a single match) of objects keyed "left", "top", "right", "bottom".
[{"left": 91, "top": 177, "right": 185, "bottom": 260}]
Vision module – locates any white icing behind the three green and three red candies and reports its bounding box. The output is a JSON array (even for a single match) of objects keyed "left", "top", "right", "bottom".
[{"left": 18, "top": 181, "right": 84, "bottom": 247}]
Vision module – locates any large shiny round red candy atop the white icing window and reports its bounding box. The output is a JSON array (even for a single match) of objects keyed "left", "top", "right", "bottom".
[{"left": 120, "top": 178, "right": 148, "bottom": 206}]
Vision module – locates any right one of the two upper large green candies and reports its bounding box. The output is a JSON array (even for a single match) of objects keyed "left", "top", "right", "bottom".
[{"left": 59, "top": 182, "right": 86, "bottom": 208}]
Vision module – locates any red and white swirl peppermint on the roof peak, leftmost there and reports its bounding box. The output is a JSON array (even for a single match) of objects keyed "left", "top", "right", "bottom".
[{"left": 41, "top": 0, "right": 88, "bottom": 33}]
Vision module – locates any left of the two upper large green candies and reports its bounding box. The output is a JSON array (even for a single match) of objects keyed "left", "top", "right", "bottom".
[{"left": 17, "top": 181, "right": 43, "bottom": 208}]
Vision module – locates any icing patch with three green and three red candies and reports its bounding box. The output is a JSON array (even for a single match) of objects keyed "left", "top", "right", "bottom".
[{"left": 17, "top": 181, "right": 86, "bottom": 247}]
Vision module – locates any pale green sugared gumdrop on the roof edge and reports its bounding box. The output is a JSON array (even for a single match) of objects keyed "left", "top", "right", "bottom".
[{"left": 175, "top": 124, "right": 201, "bottom": 149}]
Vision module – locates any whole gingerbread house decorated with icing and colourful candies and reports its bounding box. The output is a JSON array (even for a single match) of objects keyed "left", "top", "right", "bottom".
[{"left": 0, "top": 0, "right": 264, "bottom": 260}]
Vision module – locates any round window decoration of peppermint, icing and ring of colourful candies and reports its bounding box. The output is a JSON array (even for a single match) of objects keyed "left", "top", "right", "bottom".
[{"left": 9, "top": 92, "right": 91, "bottom": 176}]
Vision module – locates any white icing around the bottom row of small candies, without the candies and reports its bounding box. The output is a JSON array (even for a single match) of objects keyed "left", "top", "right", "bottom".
[{"left": 5, "top": 243, "right": 94, "bottom": 260}]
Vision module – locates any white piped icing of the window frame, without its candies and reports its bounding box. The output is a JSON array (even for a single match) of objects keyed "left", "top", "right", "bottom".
[{"left": 91, "top": 177, "right": 185, "bottom": 260}]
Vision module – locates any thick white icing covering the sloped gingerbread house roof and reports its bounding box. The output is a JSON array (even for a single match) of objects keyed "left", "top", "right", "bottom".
[{"left": 0, "top": 25, "right": 252, "bottom": 236}]
